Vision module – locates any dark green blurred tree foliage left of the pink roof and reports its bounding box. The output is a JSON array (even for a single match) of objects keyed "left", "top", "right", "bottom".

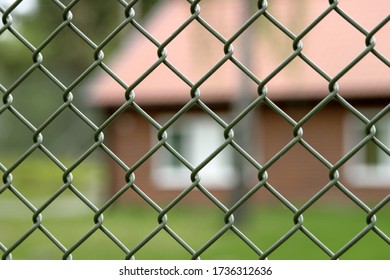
[{"left": 0, "top": 0, "right": 124, "bottom": 154}]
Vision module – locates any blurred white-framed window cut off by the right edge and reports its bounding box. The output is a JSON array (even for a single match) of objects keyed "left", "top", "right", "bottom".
[{"left": 345, "top": 109, "right": 390, "bottom": 188}]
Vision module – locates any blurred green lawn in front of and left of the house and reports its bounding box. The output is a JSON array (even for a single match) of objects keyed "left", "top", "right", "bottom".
[{"left": 0, "top": 154, "right": 390, "bottom": 259}]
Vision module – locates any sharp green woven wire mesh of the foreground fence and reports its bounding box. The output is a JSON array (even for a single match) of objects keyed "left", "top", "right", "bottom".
[{"left": 0, "top": 0, "right": 390, "bottom": 259}]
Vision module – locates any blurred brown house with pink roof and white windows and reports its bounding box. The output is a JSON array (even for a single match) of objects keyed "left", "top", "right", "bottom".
[{"left": 88, "top": 0, "right": 390, "bottom": 201}]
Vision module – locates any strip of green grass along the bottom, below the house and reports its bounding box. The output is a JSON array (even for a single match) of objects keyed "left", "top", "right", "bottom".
[{"left": 0, "top": 202, "right": 390, "bottom": 259}]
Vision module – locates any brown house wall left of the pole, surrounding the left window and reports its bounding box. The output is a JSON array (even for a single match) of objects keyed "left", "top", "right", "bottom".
[{"left": 105, "top": 106, "right": 230, "bottom": 205}]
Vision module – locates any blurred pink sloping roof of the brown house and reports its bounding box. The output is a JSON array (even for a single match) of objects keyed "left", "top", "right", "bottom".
[{"left": 88, "top": 0, "right": 390, "bottom": 106}]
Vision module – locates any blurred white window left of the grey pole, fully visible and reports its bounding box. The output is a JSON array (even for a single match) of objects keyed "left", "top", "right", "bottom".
[{"left": 152, "top": 114, "right": 236, "bottom": 189}]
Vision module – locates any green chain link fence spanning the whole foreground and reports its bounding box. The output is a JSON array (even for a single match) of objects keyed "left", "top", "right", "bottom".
[{"left": 0, "top": 0, "right": 390, "bottom": 259}]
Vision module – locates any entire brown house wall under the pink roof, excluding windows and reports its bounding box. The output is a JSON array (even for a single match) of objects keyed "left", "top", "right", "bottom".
[{"left": 105, "top": 102, "right": 389, "bottom": 206}]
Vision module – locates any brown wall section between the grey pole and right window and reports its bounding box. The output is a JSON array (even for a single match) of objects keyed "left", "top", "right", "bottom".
[{"left": 263, "top": 103, "right": 345, "bottom": 200}]
